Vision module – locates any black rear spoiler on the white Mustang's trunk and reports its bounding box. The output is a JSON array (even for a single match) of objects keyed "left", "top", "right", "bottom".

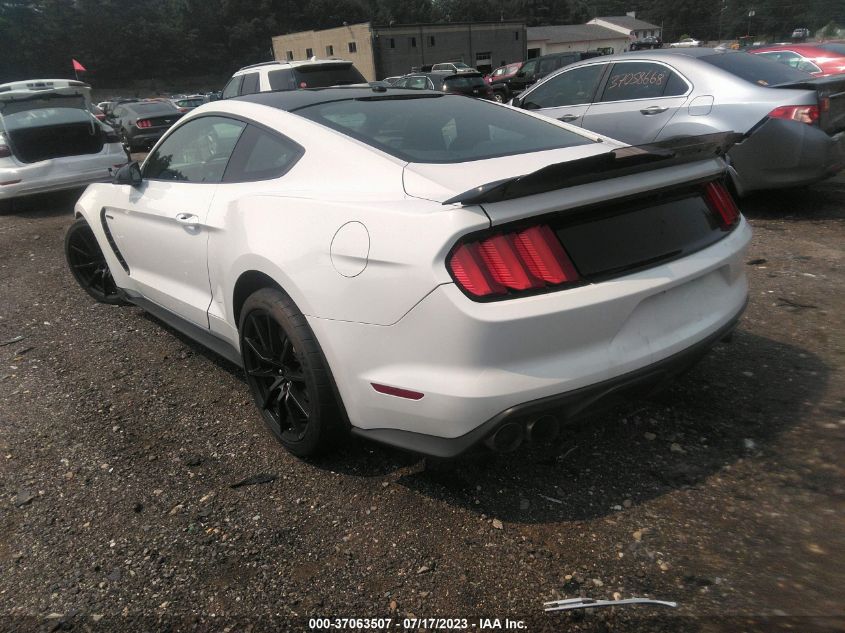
[{"left": 443, "top": 132, "right": 744, "bottom": 205}]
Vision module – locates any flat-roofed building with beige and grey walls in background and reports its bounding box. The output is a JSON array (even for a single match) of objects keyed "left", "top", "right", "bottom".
[{"left": 273, "top": 22, "right": 526, "bottom": 81}]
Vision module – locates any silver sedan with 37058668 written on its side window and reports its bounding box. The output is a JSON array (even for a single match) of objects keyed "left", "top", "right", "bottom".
[{"left": 511, "top": 48, "right": 845, "bottom": 195}]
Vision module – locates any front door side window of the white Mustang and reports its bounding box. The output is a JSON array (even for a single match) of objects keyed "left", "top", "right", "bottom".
[{"left": 144, "top": 116, "right": 246, "bottom": 183}]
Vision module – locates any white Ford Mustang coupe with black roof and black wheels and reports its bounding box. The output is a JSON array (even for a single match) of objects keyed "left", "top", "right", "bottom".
[{"left": 66, "top": 86, "right": 751, "bottom": 457}]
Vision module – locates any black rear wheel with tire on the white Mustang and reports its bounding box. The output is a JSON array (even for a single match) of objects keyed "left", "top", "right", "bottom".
[{"left": 239, "top": 288, "right": 343, "bottom": 457}]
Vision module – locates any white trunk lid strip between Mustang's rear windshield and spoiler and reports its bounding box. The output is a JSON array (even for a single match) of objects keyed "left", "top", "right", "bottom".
[{"left": 402, "top": 140, "right": 623, "bottom": 202}]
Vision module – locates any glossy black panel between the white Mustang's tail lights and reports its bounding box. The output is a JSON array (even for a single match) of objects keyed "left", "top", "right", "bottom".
[{"left": 550, "top": 186, "right": 726, "bottom": 282}]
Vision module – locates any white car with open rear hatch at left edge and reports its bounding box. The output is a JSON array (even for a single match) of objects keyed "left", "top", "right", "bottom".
[{"left": 0, "top": 79, "right": 127, "bottom": 210}]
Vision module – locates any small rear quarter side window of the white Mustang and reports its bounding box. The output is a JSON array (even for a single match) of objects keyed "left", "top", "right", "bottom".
[{"left": 223, "top": 125, "right": 304, "bottom": 182}]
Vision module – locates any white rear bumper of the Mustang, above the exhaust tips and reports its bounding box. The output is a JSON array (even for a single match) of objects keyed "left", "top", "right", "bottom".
[{"left": 309, "top": 221, "right": 751, "bottom": 457}]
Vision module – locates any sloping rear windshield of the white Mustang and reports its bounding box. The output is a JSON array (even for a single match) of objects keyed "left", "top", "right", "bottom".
[{"left": 295, "top": 95, "right": 592, "bottom": 163}]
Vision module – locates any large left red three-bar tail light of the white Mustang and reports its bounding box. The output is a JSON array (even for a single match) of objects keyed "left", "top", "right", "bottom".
[{"left": 448, "top": 224, "right": 580, "bottom": 297}]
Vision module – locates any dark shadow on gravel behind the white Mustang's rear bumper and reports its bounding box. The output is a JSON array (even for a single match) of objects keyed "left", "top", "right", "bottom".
[{"left": 397, "top": 331, "right": 830, "bottom": 523}]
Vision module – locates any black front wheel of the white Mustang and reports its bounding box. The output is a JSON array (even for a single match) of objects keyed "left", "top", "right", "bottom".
[{"left": 65, "top": 218, "right": 126, "bottom": 305}]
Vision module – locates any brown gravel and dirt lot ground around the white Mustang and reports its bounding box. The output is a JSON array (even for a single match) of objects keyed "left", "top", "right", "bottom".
[{"left": 0, "top": 177, "right": 845, "bottom": 632}]
